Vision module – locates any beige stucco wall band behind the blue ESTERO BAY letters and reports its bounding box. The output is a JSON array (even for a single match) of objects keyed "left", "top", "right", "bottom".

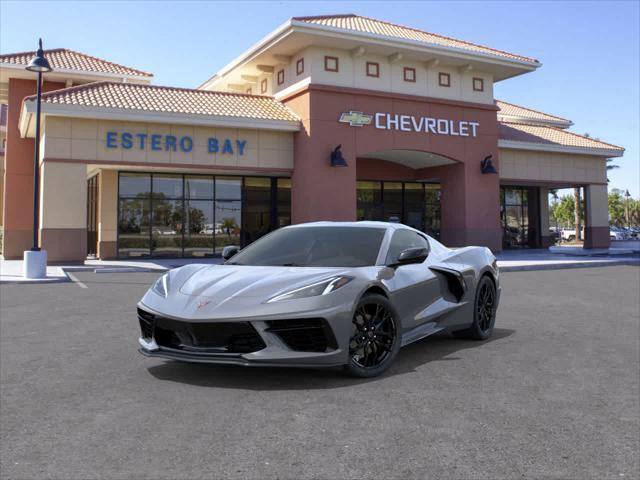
[{"left": 42, "top": 117, "right": 293, "bottom": 169}]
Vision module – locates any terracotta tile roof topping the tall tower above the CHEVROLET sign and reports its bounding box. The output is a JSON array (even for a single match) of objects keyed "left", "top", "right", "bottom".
[{"left": 293, "top": 14, "right": 539, "bottom": 63}]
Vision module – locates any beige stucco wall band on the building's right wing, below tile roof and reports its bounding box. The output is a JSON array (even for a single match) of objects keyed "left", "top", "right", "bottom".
[{"left": 499, "top": 148, "right": 607, "bottom": 184}]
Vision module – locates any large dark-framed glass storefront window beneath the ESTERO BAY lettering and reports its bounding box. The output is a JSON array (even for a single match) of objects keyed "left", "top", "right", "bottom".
[{"left": 118, "top": 172, "right": 291, "bottom": 257}]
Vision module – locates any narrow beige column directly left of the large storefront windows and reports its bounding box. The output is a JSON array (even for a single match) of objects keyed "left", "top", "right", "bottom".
[{"left": 98, "top": 170, "right": 118, "bottom": 260}]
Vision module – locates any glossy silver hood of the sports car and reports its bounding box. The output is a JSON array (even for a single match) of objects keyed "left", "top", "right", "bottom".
[{"left": 178, "top": 265, "right": 349, "bottom": 299}]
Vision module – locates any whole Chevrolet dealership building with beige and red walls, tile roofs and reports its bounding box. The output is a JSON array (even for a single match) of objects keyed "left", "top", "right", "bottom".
[{"left": 0, "top": 15, "right": 624, "bottom": 261}]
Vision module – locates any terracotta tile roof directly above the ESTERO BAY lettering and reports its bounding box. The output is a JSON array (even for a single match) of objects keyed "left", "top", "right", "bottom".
[{"left": 27, "top": 82, "right": 298, "bottom": 121}]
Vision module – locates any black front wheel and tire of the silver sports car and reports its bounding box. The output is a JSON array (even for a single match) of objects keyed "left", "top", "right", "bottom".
[{"left": 345, "top": 294, "right": 402, "bottom": 378}]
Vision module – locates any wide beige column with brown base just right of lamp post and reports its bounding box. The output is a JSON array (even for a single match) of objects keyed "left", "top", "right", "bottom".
[{"left": 40, "top": 161, "right": 87, "bottom": 262}]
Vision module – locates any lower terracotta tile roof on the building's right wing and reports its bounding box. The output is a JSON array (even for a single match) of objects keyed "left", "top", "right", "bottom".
[{"left": 498, "top": 122, "right": 624, "bottom": 153}]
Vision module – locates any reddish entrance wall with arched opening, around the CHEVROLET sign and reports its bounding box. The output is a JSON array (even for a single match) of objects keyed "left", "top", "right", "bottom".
[{"left": 284, "top": 85, "right": 502, "bottom": 251}]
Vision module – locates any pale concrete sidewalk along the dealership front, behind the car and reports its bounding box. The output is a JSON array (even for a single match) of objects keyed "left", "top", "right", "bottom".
[{"left": 0, "top": 247, "right": 640, "bottom": 283}]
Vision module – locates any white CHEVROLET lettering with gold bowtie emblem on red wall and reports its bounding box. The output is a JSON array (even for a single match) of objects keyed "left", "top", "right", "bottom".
[{"left": 338, "top": 110, "right": 480, "bottom": 137}]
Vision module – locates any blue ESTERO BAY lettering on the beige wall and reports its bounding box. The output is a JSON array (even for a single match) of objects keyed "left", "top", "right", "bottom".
[{"left": 105, "top": 132, "right": 247, "bottom": 155}]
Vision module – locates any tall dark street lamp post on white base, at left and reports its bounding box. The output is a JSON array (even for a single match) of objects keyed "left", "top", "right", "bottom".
[{"left": 24, "top": 39, "right": 53, "bottom": 278}]
